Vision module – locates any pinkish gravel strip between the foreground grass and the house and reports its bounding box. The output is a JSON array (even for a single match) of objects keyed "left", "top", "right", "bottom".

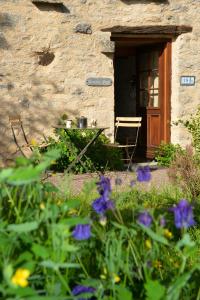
[{"left": 48, "top": 168, "right": 169, "bottom": 194}]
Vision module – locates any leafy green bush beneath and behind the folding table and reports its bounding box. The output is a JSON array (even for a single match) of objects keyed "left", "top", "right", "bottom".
[{"left": 44, "top": 129, "right": 123, "bottom": 173}]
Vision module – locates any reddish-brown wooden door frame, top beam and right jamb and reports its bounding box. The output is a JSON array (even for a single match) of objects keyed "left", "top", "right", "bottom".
[{"left": 112, "top": 36, "right": 172, "bottom": 158}]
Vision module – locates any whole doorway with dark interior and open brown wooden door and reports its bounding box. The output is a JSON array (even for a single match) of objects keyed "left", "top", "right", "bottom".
[{"left": 114, "top": 39, "right": 171, "bottom": 158}]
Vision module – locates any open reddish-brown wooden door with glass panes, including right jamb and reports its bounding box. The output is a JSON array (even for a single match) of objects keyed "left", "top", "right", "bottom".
[{"left": 137, "top": 42, "right": 171, "bottom": 158}]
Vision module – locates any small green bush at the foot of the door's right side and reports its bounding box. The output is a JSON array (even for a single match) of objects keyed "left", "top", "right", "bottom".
[{"left": 155, "top": 142, "right": 184, "bottom": 167}]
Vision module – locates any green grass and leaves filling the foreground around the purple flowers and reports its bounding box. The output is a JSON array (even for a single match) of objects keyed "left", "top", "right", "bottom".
[{"left": 0, "top": 154, "right": 200, "bottom": 300}]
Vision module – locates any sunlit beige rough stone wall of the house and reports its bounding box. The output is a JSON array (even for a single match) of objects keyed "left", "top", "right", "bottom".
[{"left": 0, "top": 0, "right": 200, "bottom": 161}]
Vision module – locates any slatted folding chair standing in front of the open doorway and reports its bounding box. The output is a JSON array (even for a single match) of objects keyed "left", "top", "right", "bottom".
[{"left": 108, "top": 117, "right": 142, "bottom": 170}]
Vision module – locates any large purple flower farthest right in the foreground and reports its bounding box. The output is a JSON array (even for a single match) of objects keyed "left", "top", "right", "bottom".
[{"left": 170, "top": 199, "right": 195, "bottom": 228}]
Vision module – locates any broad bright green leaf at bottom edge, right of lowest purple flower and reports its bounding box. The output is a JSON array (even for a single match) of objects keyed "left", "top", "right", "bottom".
[{"left": 144, "top": 279, "right": 166, "bottom": 300}]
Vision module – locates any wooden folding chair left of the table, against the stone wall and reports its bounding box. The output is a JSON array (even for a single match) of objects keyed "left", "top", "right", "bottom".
[{"left": 9, "top": 115, "right": 49, "bottom": 158}]
